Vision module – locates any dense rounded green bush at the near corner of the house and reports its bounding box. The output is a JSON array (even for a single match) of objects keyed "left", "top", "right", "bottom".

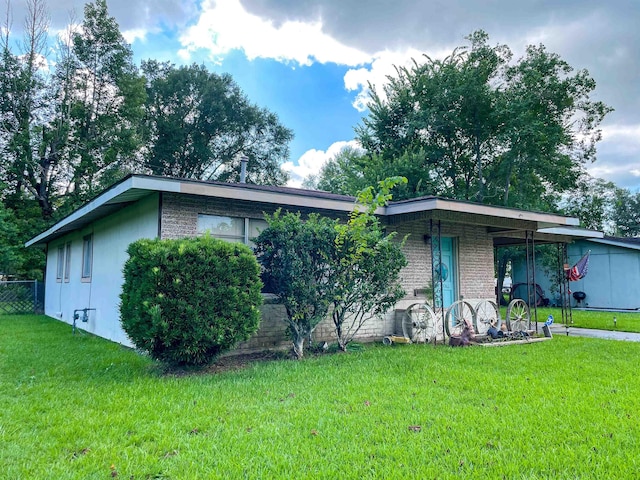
[{"left": 120, "top": 236, "right": 262, "bottom": 365}]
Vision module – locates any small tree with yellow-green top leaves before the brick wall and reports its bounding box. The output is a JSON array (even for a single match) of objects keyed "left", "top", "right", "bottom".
[{"left": 329, "top": 177, "right": 407, "bottom": 350}]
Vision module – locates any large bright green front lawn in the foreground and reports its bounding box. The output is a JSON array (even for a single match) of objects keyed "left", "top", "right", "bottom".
[{"left": 0, "top": 316, "right": 640, "bottom": 479}]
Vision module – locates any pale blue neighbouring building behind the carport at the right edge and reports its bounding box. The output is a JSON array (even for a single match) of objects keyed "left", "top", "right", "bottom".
[{"left": 516, "top": 236, "right": 640, "bottom": 311}]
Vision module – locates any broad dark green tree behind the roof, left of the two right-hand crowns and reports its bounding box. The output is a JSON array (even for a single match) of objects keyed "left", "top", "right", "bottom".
[{"left": 356, "top": 31, "right": 511, "bottom": 200}]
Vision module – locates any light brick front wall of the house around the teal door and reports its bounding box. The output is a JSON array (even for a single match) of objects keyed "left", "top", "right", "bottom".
[{"left": 160, "top": 194, "right": 495, "bottom": 351}]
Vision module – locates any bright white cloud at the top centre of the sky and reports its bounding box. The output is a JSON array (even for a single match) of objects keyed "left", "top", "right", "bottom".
[{"left": 179, "top": 0, "right": 370, "bottom": 66}]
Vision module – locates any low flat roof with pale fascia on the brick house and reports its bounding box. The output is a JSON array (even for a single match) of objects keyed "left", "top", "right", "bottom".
[{"left": 25, "top": 174, "right": 595, "bottom": 247}]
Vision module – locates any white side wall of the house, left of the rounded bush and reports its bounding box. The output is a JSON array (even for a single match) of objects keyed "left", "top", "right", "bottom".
[{"left": 45, "top": 194, "right": 158, "bottom": 346}]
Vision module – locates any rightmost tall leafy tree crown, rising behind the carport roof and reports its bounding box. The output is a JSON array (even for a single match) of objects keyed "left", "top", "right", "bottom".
[{"left": 490, "top": 45, "right": 611, "bottom": 210}]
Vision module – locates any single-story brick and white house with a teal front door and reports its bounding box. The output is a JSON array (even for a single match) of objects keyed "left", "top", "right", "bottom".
[{"left": 26, "top": 175, "right": 604, "bottom": 348}]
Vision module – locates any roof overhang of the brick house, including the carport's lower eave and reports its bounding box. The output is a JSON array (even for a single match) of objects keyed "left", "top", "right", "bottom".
[{"left": 25, "top": 175, "right": 602, "bottom": 247}]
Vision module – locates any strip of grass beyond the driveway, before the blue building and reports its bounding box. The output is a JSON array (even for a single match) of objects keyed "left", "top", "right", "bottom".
[{"left": 508, "top": 307, "right": 640, "bottom": 333}]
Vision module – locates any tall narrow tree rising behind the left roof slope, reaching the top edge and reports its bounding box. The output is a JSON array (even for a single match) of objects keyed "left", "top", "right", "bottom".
[{"left": 65, "top": 0, "right": 145, "bottom": 205}]
